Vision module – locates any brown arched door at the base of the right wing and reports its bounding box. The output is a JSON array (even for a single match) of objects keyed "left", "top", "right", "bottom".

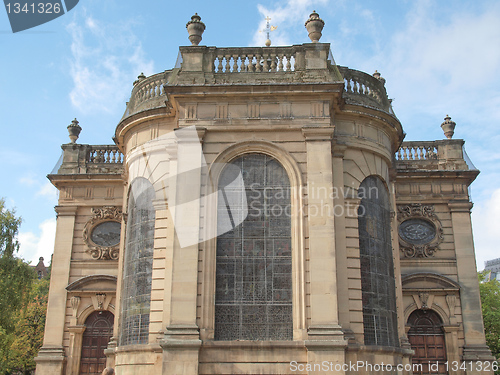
[{"left": 408, "top": 310, "right": 448, "bottom": 375}]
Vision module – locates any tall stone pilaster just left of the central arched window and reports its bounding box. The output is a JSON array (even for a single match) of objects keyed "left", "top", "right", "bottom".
[{"left": 160, "top": 131, "right": 204, "bottom": 375}]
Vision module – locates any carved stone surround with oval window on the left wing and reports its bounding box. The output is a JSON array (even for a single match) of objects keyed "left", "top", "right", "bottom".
[{"left": 83, "top": 206, "right": 123, "bottom": 260}]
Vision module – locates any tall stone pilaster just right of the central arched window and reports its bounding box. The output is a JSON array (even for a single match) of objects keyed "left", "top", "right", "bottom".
[{"left": 302, "top": 127, "right": 347, "bottom": 374}]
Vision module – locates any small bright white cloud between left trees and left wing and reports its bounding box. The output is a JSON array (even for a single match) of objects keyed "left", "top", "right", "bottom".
[{"left": 18, "top": 219, "right": 56, "bottom": 266}]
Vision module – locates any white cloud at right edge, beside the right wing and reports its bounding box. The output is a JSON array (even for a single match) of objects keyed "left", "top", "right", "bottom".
[{"left": 472, "top": 189, "right": 500, "bottom": 270}]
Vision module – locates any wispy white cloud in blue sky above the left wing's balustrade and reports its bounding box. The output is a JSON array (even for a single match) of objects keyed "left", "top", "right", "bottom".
[{"left": 67, "top": 11, "right": 154, "bottom": 113}]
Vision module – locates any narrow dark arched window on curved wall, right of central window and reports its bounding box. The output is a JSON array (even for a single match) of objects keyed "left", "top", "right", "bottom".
[{"left": 358, "top": 176, "right": 399, "bottom": 346}]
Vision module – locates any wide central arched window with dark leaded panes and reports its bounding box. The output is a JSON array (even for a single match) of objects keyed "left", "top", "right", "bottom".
[{"left": 215, "top": 154, "right": 293, "bottom": 340}]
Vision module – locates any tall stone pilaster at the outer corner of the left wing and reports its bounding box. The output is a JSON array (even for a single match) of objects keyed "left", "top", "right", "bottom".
[{"left": 35, "top": 206, "right": 77, "bottom": 375}]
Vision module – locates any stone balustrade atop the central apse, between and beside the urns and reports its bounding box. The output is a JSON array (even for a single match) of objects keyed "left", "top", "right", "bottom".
[{"left": 123, "top": 43, "right": 394, "bottom": 118}]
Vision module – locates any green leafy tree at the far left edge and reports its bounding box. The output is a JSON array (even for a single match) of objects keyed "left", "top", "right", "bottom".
[{"left": 0, "top": 199, "right": 36, "bottom": 374}]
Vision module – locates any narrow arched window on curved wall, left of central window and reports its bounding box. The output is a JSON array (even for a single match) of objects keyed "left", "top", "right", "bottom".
[{"left": 120, "top": 178, "right": 155, "bottom": 345}]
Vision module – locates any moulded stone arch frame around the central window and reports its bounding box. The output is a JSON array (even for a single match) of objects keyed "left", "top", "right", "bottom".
[{"left": 198, "top": 141, "right": 306, "bottom": 340}]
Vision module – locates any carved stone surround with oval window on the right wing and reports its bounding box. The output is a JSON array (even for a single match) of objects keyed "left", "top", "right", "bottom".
[{"left": 398, "top": 203, "right": 443, "bottom": 258}]
